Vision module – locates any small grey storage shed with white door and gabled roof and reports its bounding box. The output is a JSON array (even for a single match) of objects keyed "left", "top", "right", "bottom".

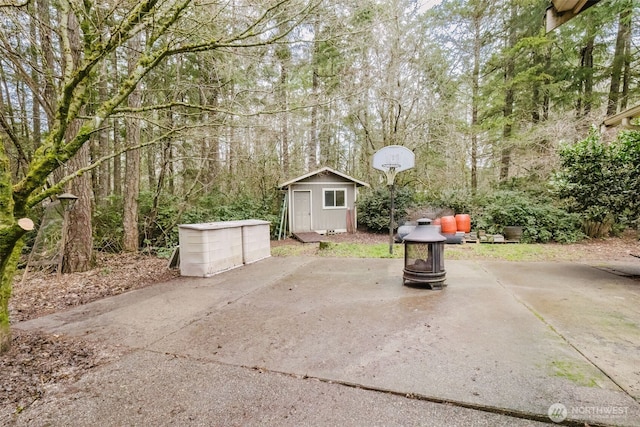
[{"left": 280, "top": 167, "right": 369, "bottom": 235}]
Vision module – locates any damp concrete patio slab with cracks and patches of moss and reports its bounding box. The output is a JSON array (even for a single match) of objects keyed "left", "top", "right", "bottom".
[{"left": 10, "top": 257, "right": 640, "bottom": 426}]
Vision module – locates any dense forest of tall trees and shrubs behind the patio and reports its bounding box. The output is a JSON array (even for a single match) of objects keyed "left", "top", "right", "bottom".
[{"left": 0, "top": 0, "right": 640, "bottom": 349}]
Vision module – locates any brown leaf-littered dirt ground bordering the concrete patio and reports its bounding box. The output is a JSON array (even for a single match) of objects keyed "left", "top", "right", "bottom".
[{"left": 0, "top": 232, "right": 640, "bottom": 423}]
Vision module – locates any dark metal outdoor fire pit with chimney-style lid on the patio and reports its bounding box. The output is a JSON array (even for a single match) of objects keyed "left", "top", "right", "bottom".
[{"left": 403, "top": 218, "right": 447, "bottom": 289}]
